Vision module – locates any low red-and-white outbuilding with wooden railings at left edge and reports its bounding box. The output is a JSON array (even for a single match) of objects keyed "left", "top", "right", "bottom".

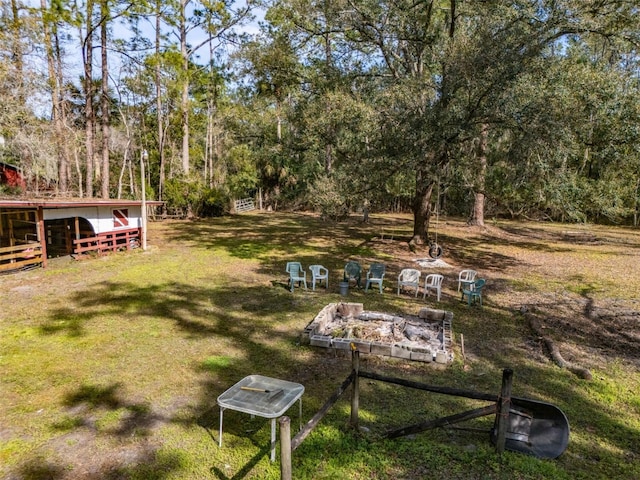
[{"left": 0, "top": 199, "right": 162, "bottom": 273}]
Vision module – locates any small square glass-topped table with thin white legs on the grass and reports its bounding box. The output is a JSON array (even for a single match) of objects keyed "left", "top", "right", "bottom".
[{"left": 218, "top": 375, "right": 304, "bottom": 462}]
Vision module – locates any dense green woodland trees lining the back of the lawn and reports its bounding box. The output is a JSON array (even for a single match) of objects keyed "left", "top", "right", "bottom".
[{"left": 0, "top": 0, "right": 640, "bottom": 231}]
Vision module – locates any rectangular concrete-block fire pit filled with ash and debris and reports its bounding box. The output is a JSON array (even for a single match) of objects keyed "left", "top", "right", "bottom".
[{"left": 304, "top": 303, "right": 453, "bottom": 363}]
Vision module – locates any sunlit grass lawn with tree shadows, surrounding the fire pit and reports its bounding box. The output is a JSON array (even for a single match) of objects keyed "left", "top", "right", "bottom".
[{"left": 0, "top": 213, "right": 640, "bottom": 480}]
